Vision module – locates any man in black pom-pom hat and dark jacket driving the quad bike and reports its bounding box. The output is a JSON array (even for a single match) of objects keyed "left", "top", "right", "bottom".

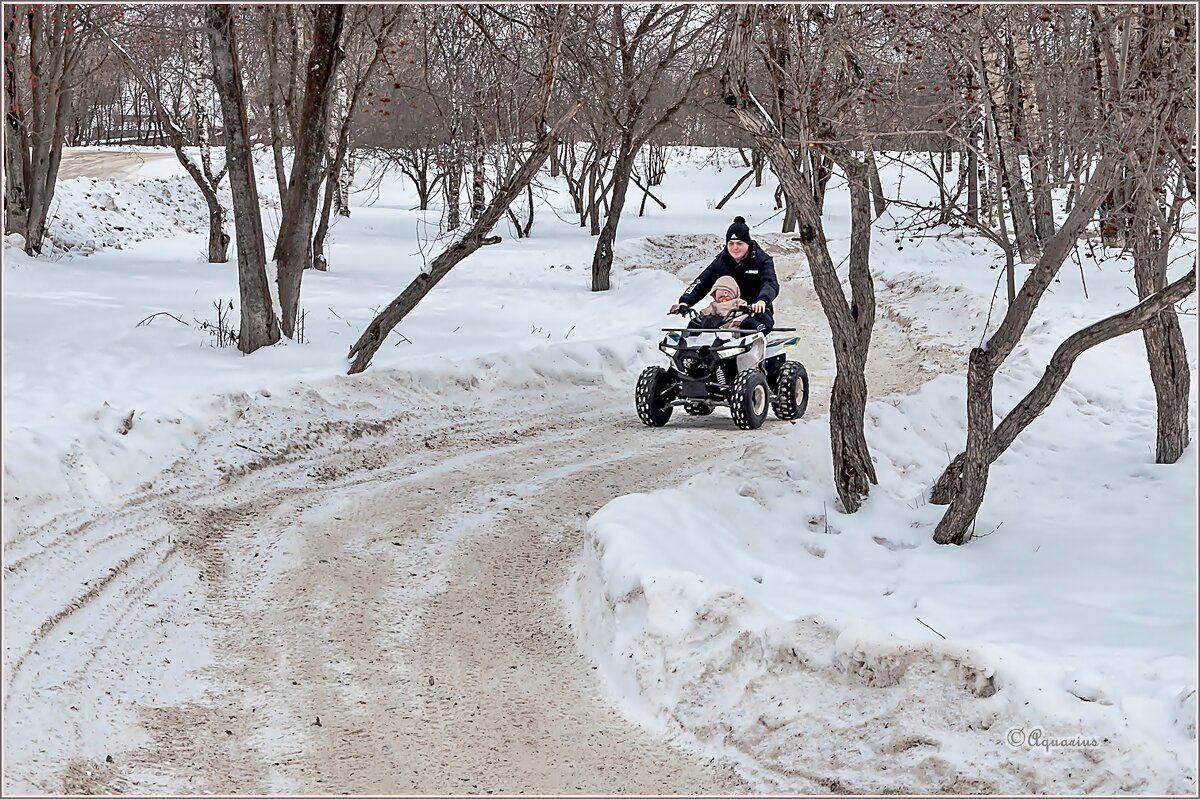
[{"left": 667, "top": 216, "right": 779, "bottom": 332}]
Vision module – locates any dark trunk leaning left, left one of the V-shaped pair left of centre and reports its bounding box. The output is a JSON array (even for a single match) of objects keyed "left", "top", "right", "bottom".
[{"left": 205, "top": 5, "right": 280, "bottom": 355}]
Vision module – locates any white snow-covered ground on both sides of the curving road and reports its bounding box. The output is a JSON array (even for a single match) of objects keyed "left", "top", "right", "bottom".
[{"left": 4, "top": 143, "right": 1198, "bottom": 792}]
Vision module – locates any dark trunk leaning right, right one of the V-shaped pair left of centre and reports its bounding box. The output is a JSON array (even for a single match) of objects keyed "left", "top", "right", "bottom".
[{"left": 274, "top": 4, "right": 346, "bottom": 338}]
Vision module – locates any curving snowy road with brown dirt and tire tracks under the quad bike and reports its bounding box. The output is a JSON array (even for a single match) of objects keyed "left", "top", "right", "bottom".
[{"left": 5, "top": 244, "right": 954, "bottom": 793}]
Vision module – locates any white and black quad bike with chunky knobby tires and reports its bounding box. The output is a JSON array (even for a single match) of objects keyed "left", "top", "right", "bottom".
[{"left": 635, "top": 310, "right": 809, "bottom": 429}]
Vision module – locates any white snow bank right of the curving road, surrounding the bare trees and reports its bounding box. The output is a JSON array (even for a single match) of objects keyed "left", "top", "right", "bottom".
[{"left": 566, "top": 164, "right": 1198, "bottom": 793}]
